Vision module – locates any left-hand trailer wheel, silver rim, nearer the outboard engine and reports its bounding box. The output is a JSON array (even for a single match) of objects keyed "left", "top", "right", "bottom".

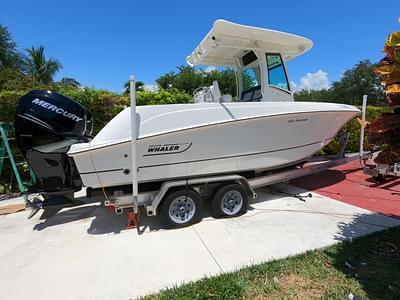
[{"left": 160, "top": 188, "right": 202, "bottom": 228}]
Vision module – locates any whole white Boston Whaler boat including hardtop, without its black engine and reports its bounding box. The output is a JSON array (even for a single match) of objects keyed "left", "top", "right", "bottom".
[{"left": 68, "top": 20, "right": 359, "bottom": 188}]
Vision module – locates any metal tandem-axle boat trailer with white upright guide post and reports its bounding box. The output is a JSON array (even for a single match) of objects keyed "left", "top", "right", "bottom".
[{"left": 88, "top": 76, "right": 359, "bottom": 228}]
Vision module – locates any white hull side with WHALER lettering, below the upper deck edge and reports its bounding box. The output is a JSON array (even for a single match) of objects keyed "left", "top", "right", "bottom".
[{"left": 69, "top": 106, "right": 357, "bottom": 188}]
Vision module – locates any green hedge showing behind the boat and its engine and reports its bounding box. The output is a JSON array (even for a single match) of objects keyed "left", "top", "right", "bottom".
[{"left": 0, "top": 86, "right": 388, "bottom": 194}]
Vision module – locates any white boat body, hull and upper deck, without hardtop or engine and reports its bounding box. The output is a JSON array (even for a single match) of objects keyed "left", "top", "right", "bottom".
[{"left": 68, "top": 102, "right": 357, "bottom": 187}]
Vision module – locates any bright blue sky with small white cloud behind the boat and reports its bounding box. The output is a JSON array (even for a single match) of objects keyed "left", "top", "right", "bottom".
[{"left": 0, "top": 0, "right": 400, "bottom": 91}]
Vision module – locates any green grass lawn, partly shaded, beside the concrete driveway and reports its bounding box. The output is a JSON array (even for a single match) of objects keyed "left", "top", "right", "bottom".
[{"left": 143, "top": 227, "right": 400, "bottom": 299}]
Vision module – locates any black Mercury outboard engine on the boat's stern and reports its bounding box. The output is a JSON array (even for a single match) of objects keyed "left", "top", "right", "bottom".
[{"left": 15, "top": 90, "right": 93, "bottom": 204}]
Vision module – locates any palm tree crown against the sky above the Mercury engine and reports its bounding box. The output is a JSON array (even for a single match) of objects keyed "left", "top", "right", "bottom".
[{"left": 25, "top": 46, "right": 62, "bottom": 84}]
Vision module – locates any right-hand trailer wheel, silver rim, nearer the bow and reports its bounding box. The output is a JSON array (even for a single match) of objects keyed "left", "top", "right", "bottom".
[{"left": 211, "top": 183, "right": 249, "bottom": 218}]
